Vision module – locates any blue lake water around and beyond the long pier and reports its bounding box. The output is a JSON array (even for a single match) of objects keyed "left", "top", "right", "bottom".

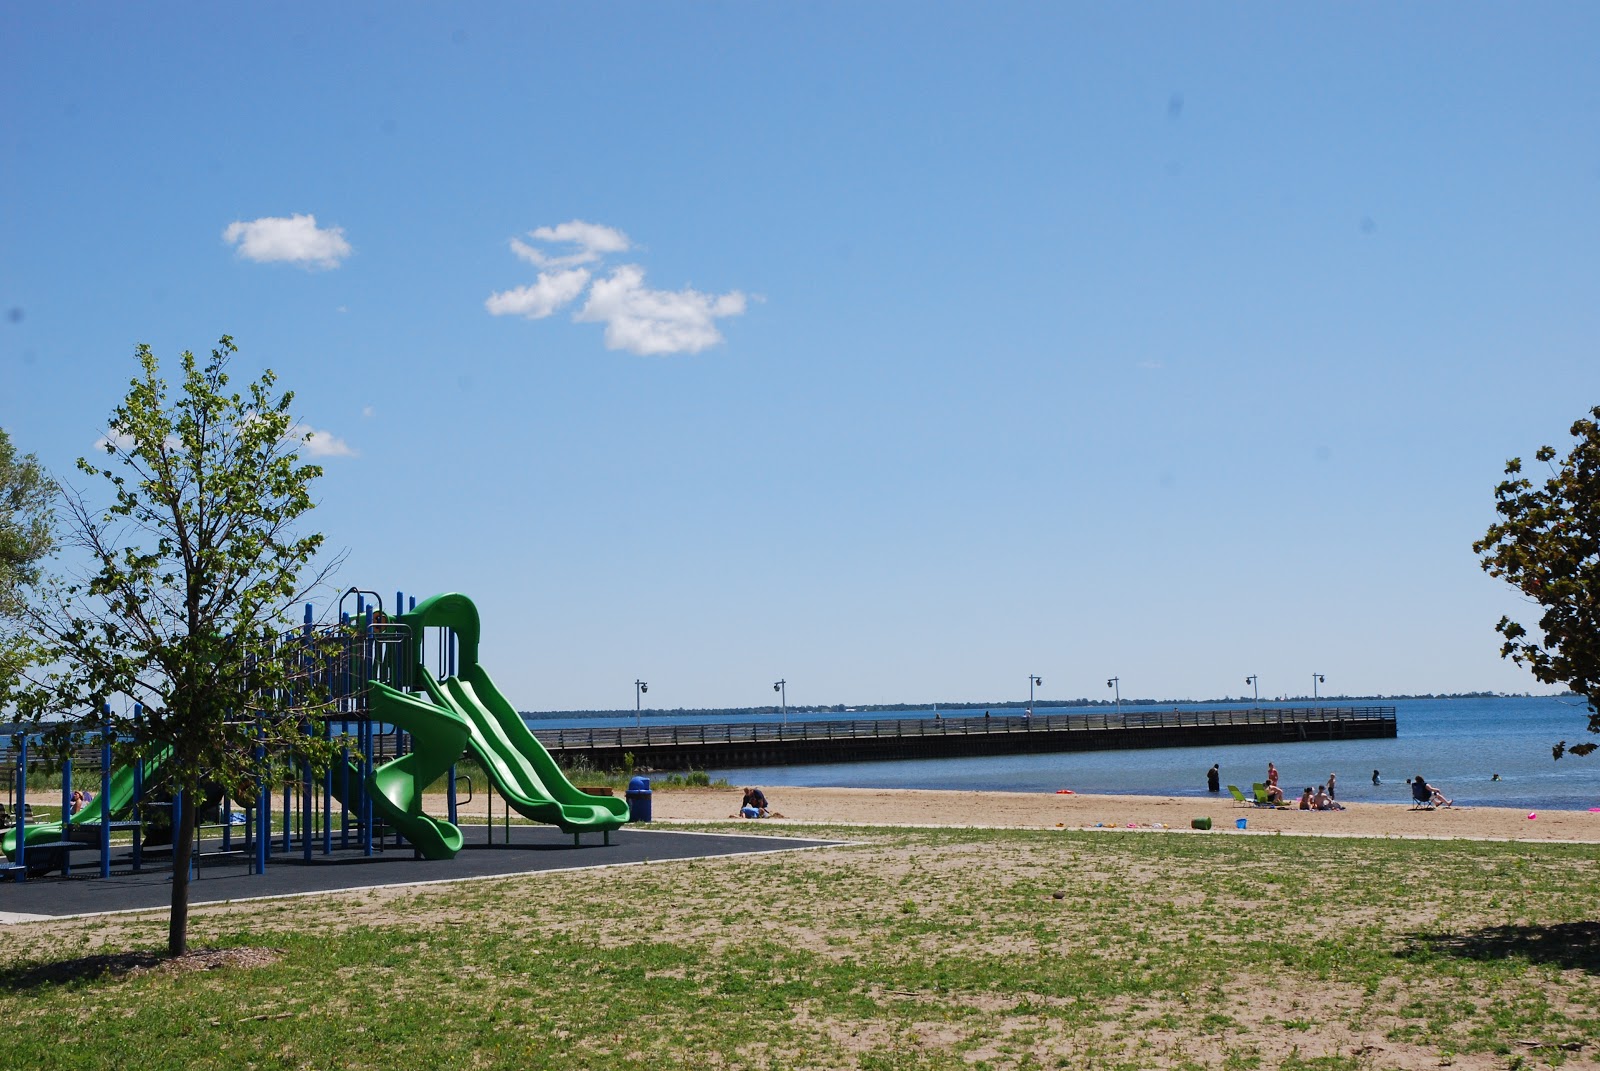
[{"left": 534, "top": 696, "right": 1600, "bottom": 810}]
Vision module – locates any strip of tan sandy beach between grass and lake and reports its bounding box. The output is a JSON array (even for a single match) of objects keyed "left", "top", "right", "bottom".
[{"left": 630, "top": 788, "right": 1600, "bottom": 844}]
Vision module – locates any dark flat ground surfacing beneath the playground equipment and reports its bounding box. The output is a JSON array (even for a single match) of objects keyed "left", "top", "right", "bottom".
[{"left": 0, "top": 826, "right": 837, "bottom": 924}]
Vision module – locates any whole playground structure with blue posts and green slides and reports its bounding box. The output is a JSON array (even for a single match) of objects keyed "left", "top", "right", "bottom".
[{"left": 0, "top": 588, "right": 629, "bottom": 880}]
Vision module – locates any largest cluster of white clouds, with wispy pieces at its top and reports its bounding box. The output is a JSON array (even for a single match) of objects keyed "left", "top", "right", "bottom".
[{"left": 483, "top": 219, "right": 749, "bottom": 355}]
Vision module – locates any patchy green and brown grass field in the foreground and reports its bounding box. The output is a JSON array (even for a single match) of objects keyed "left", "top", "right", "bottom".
[{"left": 0, "top": 828, "right": 1600, "bottom": 1071}]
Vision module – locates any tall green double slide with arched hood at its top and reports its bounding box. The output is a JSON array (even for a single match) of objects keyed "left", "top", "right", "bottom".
[{"left": 397, "top": 594, "right": 629, "bottom": 834}]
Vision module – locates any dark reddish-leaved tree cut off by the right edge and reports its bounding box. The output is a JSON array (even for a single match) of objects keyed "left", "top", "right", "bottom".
[{"left": 1472, "top": 405, "right": 1600, "bottom": 759}]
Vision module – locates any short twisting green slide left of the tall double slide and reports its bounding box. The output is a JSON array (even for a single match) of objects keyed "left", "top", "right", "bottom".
[{"left": 350, "top": 680, "right": 472, "bottom": 860}]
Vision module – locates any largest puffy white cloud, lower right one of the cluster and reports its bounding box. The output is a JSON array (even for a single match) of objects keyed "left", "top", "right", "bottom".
[{"left": 573, "top": 264, "right": 746, "bottom": 355}]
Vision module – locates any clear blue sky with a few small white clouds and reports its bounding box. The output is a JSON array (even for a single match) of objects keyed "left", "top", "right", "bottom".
[{"left": 0, "top": 3, "right": 1600, "bottom": 709}]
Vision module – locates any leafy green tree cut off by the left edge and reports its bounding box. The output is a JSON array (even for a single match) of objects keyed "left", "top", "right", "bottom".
[{"left": 0, "top": 427, "right": 54, "bottom": 703}]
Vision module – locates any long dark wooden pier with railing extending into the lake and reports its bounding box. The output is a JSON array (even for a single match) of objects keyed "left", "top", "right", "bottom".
[{"left": 521, "top": 706, "right": 1395, "bottom": 770}]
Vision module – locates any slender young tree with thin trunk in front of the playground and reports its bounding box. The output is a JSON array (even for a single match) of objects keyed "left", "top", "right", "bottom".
[{"left": 19, "top": 336, "right": 347, "bottom": 956}]
